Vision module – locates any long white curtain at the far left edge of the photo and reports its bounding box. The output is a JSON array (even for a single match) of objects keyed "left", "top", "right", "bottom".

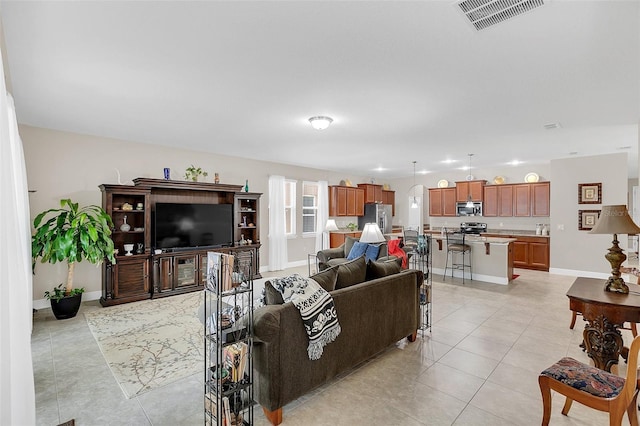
[{"left": 0, "top": 55, "right": 36, "bottom": 425}]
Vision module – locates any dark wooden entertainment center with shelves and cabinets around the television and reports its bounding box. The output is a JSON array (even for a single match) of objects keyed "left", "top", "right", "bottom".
[{"left": 100, "top": 178, "right": 262, "bottom": 306}]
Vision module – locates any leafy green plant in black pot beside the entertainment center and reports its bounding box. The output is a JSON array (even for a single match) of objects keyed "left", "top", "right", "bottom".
[{"left": 31, "top": 199, "right": 116, "bottom": 319}]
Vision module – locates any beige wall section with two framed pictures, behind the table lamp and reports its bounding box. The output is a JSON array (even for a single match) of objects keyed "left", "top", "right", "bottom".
[{"left": 551, "top": 153, "right": 628, "bottom": 278}]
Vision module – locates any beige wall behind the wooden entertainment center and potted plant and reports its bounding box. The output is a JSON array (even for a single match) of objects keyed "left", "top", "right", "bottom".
[{"left": 20, "top": 125, "right": 366, "bottom": 300}]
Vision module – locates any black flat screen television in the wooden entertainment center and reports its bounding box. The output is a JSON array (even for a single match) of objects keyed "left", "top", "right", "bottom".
[{"left": 153, "top": 203, "right": 233, "bottom": 249}]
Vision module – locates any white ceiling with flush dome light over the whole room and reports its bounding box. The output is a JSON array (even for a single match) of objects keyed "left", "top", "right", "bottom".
[{"left": 0, "top": 0, "right": 640, "bottom": 178}]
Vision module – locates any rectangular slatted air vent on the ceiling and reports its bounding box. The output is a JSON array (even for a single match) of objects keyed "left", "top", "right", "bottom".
[{"left": 458, "top": 0, "right": 544, "bottom": 31}]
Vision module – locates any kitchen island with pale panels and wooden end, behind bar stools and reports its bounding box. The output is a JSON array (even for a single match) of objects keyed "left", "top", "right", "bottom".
[{"left": 428, "top": 231, "right": 516, "bottom": 285}]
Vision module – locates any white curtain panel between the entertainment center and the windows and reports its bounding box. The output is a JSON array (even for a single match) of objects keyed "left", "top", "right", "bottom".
[{"left": 269, "top": 176, "right": 287, "bottom": 271}]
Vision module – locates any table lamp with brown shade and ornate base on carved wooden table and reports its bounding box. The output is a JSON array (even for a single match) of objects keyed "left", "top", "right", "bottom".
[{"left": 589, "top": 204, "right": 640, "bottom": 294}]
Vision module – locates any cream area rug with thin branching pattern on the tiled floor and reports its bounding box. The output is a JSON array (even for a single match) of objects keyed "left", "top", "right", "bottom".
[{"left": 84, "top": 291, "right": 204, "bottom": 398}]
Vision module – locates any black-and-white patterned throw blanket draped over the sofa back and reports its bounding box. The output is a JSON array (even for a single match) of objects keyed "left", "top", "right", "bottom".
[{"left": 271, "top": 274, "right": 341, "bottom": 361}]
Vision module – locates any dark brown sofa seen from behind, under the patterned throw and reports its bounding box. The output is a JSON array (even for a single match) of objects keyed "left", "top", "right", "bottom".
[{"left": 253, "top": 260, "right": 423, "bottom": 425}]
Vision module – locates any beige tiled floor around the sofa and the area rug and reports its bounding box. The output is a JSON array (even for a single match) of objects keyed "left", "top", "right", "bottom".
[{"left": 32, "top": 266, "right": 631, "bottom": 426}]
